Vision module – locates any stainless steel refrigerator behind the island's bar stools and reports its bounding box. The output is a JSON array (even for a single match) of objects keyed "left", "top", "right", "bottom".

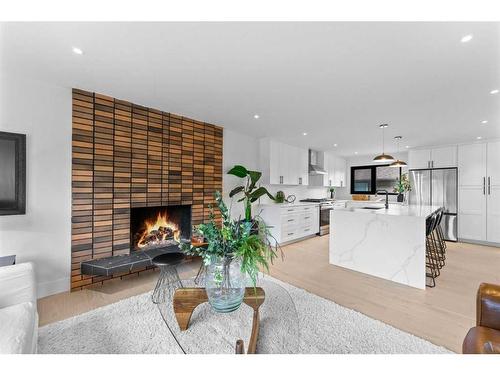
[{"left": 408, "top": 168, "right": 458, "bottom": 241}]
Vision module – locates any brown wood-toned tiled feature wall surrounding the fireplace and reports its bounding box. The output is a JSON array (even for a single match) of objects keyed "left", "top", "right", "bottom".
[{"left": 71, "top": 89, "right": 222, "bottom": 290}]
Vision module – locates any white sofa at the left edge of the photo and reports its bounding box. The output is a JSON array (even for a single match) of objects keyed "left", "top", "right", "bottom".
[{"left": 0, "top": 263, "right": 38, "bottom": 354}]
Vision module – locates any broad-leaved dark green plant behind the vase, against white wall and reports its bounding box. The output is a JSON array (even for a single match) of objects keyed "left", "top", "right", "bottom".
[{"left": 227, "top": 165, "right": 275, "bottom": 221}]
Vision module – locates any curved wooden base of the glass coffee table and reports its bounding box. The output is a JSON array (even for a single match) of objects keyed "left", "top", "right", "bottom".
[{"left": 174, "top": 288, "right": 265, "bottom": 354}]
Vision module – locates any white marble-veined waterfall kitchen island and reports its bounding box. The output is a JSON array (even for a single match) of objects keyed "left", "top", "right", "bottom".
[{"left": 329, "top": 204, "right": 439, "bottom": 289}]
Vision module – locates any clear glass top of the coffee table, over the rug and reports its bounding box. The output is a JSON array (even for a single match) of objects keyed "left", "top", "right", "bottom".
[{"left": 157, "top": 277, "right": 300, "bottom": 354}]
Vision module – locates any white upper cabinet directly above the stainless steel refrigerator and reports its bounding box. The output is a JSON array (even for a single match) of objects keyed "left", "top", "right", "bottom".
[{"left": 408, "top": 146, "right": 457, "bottom": 169}]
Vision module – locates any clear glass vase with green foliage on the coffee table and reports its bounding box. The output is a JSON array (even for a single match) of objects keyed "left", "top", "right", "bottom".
[{"left": 181, "top": 192, "right": 279, "bottom": 312}]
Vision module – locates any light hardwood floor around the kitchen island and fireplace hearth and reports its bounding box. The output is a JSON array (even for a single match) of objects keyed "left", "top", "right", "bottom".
[{"left": 38, "top": 236, "right": 500, "bottom": 352}]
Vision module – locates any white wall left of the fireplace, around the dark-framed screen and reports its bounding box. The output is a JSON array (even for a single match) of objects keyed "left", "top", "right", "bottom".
[{"left": 0, "top": 74, "right": 71, "bottom": 297}]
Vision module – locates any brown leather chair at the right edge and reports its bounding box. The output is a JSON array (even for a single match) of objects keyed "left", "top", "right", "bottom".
[{"left": 462, "top": 283, "right": 500, "bottom": 354}]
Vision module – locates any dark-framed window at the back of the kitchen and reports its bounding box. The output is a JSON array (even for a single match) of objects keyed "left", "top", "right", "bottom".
[{"left": 351, "top": 164, "right": 401, "bottom": 194}]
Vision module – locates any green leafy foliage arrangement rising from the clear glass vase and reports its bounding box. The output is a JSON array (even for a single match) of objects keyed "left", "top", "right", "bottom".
[{"left": 181, "top": 192, "right": 280, "bottom": 286}]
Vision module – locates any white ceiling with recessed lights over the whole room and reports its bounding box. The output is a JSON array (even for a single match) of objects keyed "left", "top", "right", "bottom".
[{"left": 0, "top": 22, "right": 500, "bottom": 156}]
